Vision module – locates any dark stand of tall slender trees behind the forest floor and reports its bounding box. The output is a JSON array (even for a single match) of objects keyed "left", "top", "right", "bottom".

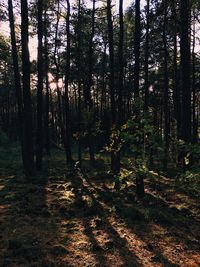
[{"left": 0, "top": 0, "right": 200, "bottom": 198}]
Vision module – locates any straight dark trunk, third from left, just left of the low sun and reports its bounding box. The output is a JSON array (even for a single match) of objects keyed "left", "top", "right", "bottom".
[{"left": 36, "top": 0, "right": 43, "bottom": 171}]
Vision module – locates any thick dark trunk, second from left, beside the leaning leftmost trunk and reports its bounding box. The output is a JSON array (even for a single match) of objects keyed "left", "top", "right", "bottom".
[{"left": 21, "top": 0, "right": 34, "bottom": 176}]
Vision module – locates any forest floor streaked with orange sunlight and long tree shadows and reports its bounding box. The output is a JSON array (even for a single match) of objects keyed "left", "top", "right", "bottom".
[{"left": 0, "top": 147, "right": 200, "bottom": 267}]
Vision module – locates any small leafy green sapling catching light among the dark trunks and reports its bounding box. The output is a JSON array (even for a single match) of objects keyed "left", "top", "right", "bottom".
[{"left": 120, "top": 103, "right": 163, "bottom": 169}]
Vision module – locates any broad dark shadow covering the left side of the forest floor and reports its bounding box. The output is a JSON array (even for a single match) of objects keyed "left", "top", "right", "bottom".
[{"left": 0, "top": 150, "right": 71, "bottom": 267}]
